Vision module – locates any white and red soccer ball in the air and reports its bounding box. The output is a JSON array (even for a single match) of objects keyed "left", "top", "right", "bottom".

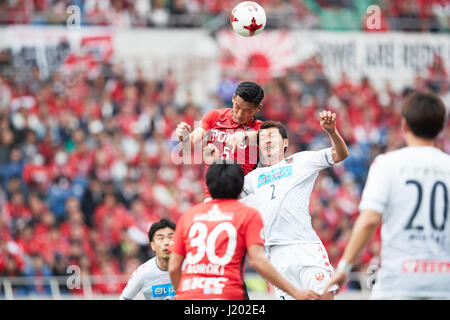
[{"left": 230, "top": 1, "right": 266, "bottom": 37}]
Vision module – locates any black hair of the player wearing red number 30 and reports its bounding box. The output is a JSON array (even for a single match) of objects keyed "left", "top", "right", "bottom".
[{"left": 206, "top": 163, "right": 244, "bottom": 199}]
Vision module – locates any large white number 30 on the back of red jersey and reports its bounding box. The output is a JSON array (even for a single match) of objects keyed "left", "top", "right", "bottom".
[{"left": 186, "top": 222, "right": 237, "bottom": 265}]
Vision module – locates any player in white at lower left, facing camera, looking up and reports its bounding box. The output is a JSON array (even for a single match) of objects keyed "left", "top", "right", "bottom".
[{"left": 120, "top": 219, "right": 175, "bottom": 300}]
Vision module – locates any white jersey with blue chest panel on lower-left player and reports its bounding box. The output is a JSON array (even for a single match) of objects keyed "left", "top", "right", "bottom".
[{"left": 120, "top": 257, "right": 175, "bottom": 300}]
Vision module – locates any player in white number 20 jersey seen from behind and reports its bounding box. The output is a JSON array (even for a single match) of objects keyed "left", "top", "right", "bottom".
[{"left": 329, "top": 91, "right": 450, "bottom": 300}]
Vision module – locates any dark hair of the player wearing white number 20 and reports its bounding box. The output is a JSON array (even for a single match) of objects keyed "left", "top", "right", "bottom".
[{"left": 402, "top": 91, "right": 446, "bottom": 139}]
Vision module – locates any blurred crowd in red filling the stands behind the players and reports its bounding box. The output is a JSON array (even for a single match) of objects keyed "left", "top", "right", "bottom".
[{"left": 0, "top": 0, "right": 450, "bottom": 295}]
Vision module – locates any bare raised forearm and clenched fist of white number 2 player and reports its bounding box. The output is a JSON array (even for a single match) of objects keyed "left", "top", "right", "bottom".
[{"left": 319, "top": 111, "right": 348, "bottom": 163}]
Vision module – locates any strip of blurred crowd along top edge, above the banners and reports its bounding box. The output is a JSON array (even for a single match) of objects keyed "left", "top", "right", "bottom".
[{"left": 0, "top": 0, "right": 450, "bottom": 32}]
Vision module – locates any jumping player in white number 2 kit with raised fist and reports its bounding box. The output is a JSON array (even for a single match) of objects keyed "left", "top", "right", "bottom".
[{"left": 242, "top": 111, "right": 348, "bottom": 299}]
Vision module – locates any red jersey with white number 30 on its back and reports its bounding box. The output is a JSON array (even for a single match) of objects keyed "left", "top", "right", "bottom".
[{"left": 170, "top": 199, "right": 264, "bottom": 300}]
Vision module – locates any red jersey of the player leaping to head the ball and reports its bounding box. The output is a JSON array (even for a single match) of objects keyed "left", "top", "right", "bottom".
[{"left": 202, "top": 108, "right": 263, "bottom": 198}]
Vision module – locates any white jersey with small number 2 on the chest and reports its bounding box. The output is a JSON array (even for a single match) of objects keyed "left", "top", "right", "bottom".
[{"left": 242, "top": 148, "right": 334, "bottom": 245}]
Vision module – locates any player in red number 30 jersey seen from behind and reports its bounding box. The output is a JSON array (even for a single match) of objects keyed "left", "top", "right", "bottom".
[{"left": 169, "top": 164, "right": 319, "bottom": 300}]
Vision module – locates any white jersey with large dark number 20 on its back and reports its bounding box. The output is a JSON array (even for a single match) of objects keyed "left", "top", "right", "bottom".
[{"left": 359, "top": 147, "right": 450, "bottom": 299}]
